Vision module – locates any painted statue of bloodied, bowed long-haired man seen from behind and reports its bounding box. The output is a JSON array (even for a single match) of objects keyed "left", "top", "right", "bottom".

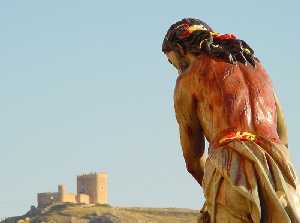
[{"left": 162, "top": 18, "right": 300, "bottom": 223}]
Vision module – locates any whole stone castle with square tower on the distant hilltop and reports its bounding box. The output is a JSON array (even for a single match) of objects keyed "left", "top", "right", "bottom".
[{"left": 37, "top": 173, "right": 108, "bottom": 207}]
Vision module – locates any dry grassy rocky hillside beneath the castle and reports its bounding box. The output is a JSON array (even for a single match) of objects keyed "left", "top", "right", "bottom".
[{"left": 1, "top": 204, "right": 199, "bottom": 223}]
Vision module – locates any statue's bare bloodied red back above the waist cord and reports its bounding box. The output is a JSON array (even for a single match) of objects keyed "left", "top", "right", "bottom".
[{"left": 175, "top": 55, "right": 279, "bottom": 142}]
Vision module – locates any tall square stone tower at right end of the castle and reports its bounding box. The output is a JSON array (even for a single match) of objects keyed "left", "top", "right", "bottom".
[{"left": 77, "top": 173, "right": 108, "bottom": 204}]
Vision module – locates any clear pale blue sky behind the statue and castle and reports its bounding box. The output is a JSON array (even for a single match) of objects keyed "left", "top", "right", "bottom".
[{"left": 0, "top": 0, "right": 300, "bottom": 218}]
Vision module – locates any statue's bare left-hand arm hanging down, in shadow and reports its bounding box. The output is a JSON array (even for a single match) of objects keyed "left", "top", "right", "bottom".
[{"left": 174, "top": 82, "right": 206, "bottom": 185}]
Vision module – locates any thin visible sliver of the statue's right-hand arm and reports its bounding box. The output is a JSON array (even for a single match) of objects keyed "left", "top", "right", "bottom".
[{"left": 274, "top": 92, "right": 288, "bottom": 147}]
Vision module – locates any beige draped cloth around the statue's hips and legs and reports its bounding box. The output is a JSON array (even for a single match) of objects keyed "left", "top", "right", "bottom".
[{"left": 199, "top": 136, "right": 300, "bottom": 223}]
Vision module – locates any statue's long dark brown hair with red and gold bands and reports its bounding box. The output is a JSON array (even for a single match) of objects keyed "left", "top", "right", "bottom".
[{"left": 162, "top": 18, "right": 258, "bottom": 66}]
